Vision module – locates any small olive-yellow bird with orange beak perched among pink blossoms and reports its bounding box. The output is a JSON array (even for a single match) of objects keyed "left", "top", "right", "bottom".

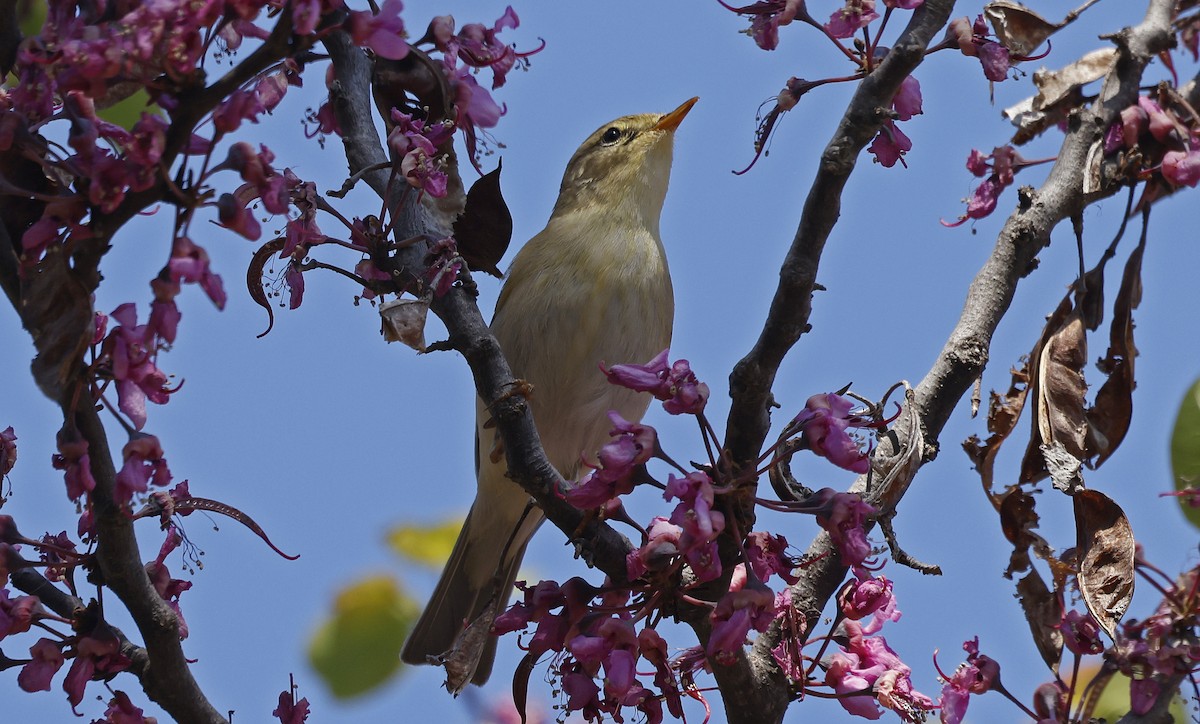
[{"left": 401, "top": 98, "right": 697, "bottom": 693}]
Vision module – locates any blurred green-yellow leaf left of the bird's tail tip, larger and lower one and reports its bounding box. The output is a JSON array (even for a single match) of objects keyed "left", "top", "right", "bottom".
[{"left": 308, "top": 575, "right": 419, "bottom": 699}]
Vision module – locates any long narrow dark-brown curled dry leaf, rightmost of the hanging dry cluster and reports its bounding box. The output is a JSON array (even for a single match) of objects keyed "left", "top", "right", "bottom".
[{"left": 1087, "top": 238, "right": 1146, "bottom": 467}]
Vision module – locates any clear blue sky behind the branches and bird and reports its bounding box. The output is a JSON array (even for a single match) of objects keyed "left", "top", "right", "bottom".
[{"left": 0, "top": 0, "right": 1200, "bottom": 723}]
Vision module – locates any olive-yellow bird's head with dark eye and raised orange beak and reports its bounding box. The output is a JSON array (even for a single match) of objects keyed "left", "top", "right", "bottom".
[{"left": 554, "top": 98, "right": 698, "bottom": 227}]
